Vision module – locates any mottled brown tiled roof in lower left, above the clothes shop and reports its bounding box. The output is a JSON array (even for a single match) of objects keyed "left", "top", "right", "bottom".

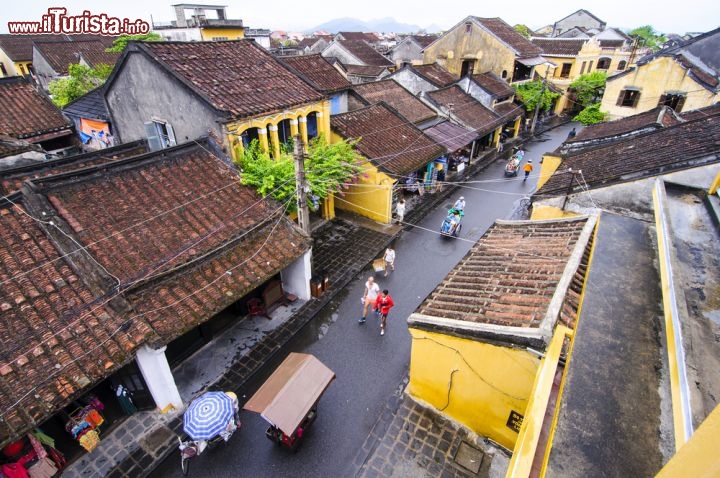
[{"left": 0, "top": 194, "right": 152, "bottom": 443}]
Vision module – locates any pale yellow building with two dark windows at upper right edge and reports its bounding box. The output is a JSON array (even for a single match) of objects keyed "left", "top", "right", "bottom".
[{"left": 601, "top": 29, "right": 720, "bottom": 119}]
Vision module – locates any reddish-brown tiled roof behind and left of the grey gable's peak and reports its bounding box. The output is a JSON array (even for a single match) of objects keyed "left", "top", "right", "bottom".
[{"left": 35, "top": 40, "right": 120, "bottom": 75}]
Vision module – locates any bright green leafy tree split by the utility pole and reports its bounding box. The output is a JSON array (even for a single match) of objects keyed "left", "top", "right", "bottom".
[{"left": 238, "top": 136, "right": 362, "bottom": 211}]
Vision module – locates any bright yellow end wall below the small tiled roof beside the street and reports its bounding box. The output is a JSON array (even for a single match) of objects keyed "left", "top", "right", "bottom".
[{"left": 408, "top": 327, "right": 539, "bottom": 450}]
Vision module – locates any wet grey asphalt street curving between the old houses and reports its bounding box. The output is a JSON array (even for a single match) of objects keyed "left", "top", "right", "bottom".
[{"left": 152, "top": 124, "right": 573, "bottom": 477}]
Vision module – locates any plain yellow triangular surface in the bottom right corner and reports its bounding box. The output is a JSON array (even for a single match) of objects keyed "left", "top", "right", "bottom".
[{"left": 655, "top": 405, "right": 720, "bottom": 478}]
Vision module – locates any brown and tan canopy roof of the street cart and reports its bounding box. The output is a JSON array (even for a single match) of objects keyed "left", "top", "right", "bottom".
[{"left": 243, "top": 352, "right": 335, "bottom": 436}]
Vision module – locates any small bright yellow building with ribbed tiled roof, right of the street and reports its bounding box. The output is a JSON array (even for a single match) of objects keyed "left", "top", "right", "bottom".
[{"left": 407, "top": 217, "right": 596, "bottom": 450}]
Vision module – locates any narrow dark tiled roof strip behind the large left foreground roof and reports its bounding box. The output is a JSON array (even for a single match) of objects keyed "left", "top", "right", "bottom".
[{"left": 0, "top": 141, "right": 148, "bottom": 195}]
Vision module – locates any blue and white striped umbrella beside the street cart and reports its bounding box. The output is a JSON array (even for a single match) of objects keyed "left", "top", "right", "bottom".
[{"left": 183, "top": 392, "right": 235, "bottom": 440}]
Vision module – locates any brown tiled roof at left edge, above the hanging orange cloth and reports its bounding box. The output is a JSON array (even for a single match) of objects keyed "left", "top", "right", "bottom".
[{"left": 0, "top": 77, "right": 72, "bottom": 139}]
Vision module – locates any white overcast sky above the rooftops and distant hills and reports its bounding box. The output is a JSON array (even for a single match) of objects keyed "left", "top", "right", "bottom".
[{"left": 0, "top": 0, "right": 720, "bottom": 34}]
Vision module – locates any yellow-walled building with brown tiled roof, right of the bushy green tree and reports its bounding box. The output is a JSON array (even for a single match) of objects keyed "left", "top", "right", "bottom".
[{"left": 330, "top": 101, "right": 445, "bottom": 224}]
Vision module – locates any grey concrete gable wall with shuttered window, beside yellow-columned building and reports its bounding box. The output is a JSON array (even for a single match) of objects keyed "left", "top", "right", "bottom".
[{"left": 105, "top": 53, "right": 223, "bottom": 144}]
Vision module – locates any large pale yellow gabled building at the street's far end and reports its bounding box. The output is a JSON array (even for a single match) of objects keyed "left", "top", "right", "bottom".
[{"left": 423, "top": 16, "right": 545, "bottom": 82}]
